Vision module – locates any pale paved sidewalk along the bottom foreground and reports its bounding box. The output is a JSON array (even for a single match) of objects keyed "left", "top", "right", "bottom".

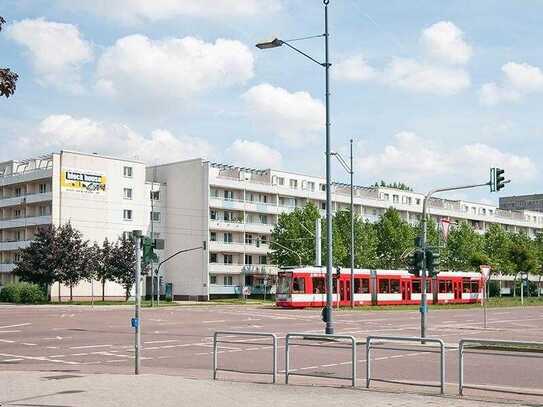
[{"left": 0, "top": 371, "right": 533, "bottom": 407}]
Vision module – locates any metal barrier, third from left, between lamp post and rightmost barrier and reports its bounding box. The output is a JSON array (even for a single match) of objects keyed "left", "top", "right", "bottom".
[{"left": 366, "top": 336, "right": 445, "bottom": 394}]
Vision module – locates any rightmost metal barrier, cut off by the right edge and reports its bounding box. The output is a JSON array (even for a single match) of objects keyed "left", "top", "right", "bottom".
[{"left": 458, "top": 339, "right": 543, "bottom": 396}]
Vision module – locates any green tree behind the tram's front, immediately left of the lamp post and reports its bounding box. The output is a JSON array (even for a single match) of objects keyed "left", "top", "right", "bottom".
[{"left": 269, "top": 203, "right": 325, "bottom": 267}]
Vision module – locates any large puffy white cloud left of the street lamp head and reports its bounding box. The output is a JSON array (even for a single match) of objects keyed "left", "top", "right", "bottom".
[{"left": 97, "top": 35, "right": 254, "bottom": 103}]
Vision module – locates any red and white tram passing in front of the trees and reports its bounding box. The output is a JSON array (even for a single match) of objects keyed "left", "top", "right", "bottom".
[{"left": 276, "top": 267, "right": 483, "bottom": 308}]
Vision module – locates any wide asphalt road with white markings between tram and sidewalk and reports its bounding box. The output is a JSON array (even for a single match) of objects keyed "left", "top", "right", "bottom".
[{"left": 0, "top": 305, "right": 543, "bottom": 402}]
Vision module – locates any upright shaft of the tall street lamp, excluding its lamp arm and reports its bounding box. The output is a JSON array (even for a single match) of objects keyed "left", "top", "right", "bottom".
[{"left": 323, "top": 0, "right": 334, "bottom": 335}]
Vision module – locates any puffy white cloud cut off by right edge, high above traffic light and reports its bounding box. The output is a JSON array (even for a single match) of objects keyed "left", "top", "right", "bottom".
[{"left": 479, "top": 62, "right": 543, "bottom": 106}]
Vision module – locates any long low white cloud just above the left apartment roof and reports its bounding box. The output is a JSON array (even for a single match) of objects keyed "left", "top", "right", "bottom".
[{"left": 29, "top": 114, "right": 215, "bottom": 163}]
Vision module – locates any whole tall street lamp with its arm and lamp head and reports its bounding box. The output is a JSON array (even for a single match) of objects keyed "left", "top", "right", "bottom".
[{"left": 256, "top": 0, "right": 334, "bottom": 334}]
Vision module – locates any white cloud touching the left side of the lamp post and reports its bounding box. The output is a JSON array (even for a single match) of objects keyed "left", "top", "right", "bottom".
[{"left": 242, "top": 84, "right": 325, "bottom": 147}]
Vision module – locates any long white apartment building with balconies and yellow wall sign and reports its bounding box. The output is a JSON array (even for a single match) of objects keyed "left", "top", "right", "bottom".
[{"left": 0, "top": 151, "right": 543, "bottom": 300}]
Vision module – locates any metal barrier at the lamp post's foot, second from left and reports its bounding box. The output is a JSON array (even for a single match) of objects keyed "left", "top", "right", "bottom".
[{"left": 285, "top": 333, "right": 356, "bottom": 387}]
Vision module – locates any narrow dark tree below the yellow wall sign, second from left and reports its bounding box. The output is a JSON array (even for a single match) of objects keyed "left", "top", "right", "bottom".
[{"left": 56, "top": 223, "right": 88, "bottom": 301}]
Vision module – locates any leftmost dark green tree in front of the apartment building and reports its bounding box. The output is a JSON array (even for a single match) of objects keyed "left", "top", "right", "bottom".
[{"left": 13, "top": 225, "right": 61, "bottom": 290}]
